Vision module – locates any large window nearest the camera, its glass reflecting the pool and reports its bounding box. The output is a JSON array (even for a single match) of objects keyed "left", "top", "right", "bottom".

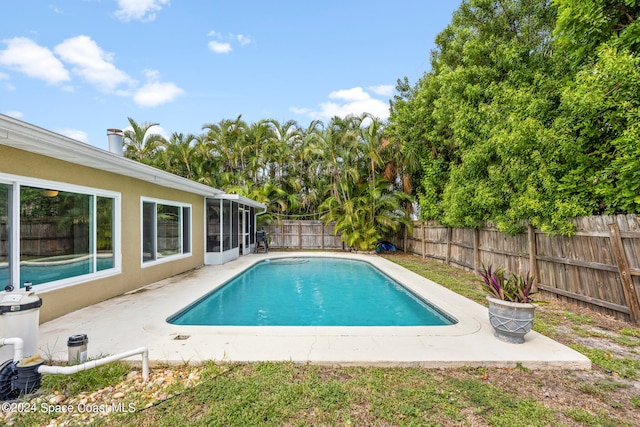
[{"left": 0, "top": 175, "right": 120, "bottom": 289}]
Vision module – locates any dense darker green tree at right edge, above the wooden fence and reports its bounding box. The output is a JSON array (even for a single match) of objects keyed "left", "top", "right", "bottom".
[{"left": 556, "top": 44, "right": 640, "bottom": 214}]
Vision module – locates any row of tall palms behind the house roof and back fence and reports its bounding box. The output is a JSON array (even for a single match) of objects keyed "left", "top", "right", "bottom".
[{"left": 121, "top": 114, "right": 411, "bottom": 244}]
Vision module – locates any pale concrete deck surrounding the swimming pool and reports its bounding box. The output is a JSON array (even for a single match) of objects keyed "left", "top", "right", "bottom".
[{"left": 38, "top": 252, "right": 591, "bottom": 370}]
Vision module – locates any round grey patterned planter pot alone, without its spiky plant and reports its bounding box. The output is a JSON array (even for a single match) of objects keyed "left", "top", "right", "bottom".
[{"left": 487, "top": 296, "right": 536, "bottom": 344}]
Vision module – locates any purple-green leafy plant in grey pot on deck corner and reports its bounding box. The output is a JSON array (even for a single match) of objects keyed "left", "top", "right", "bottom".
[{"left": 480, "top": 264, "right": 536, "bottom": 344}]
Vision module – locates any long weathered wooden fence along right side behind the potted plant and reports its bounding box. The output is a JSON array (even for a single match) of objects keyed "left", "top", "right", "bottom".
[{"left": 393, "top": 215, "right": 640, "bottom": 325}]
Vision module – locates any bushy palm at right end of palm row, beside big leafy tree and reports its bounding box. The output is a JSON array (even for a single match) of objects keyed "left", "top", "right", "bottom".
[{"left": 320, "top": 114, "right": 411, "bottom": 250}]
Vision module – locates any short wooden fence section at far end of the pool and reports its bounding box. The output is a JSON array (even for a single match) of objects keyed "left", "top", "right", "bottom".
[{"left": 264, "top": 220, "right": 344, "bottom": 249}]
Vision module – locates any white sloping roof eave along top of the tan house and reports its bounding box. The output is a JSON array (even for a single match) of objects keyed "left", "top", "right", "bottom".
[{"left": 0, "top": 114, "right": 226, "bottom": 199}]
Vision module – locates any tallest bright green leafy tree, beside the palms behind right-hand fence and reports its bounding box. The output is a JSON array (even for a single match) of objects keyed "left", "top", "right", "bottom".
[{"left": 388, "top": 0, "right": 580, "bottom": 232}]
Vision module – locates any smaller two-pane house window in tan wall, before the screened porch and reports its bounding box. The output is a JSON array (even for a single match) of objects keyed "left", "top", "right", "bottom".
[{"left": 142, "top": 200, "right": 191, "bottom": 263}]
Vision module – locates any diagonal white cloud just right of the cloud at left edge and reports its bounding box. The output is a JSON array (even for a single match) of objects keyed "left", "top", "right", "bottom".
[{"left": 54, "top": 36, "right": 133, "bottom": 93}]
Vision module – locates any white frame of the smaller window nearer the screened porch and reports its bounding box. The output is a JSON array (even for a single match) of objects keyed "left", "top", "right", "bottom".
[{"left": 140, "top": 196, "right": 193, "bottom": 268}]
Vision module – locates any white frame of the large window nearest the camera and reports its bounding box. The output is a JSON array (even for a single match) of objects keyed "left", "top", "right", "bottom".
[{"left": 0, "top": 173, "right": 122, "bottom": 292}]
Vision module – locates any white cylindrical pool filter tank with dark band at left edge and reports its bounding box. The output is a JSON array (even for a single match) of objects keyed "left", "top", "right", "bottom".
[{"left": 0, "top": 283, "right": 42, "bottom": 363}]
